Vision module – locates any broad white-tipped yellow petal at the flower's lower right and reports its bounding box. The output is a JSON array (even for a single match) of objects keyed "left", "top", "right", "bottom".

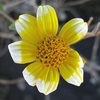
[{"left": 59, "top": 49, "right": 84, "bottom": 86}]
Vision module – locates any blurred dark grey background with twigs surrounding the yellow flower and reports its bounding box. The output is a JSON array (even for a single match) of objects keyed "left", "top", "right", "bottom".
[{"left": 0, "top": 0, "right": 100, "bottom": 100}]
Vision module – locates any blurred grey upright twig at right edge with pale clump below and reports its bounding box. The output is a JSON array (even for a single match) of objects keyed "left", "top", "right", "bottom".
[{"left": 85, "top": 23, "right": 100, "bottom": 83}]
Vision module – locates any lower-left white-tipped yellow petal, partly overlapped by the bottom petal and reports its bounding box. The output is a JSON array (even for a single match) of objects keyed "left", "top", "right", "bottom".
[{"left": 23, "top": 62, "right": 42, "bottom": 86}]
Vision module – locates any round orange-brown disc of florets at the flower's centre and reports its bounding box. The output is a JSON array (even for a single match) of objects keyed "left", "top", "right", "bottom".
[{"left": 36, "top": 36, "right": 69, "bottom": 67}]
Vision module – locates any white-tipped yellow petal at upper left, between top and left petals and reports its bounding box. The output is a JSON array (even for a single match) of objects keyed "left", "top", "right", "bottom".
[{"left": 15, "top": 14, "right": 41, "bottom": 43}]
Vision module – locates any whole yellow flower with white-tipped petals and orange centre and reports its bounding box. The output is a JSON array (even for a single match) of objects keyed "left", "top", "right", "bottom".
[{"left": 8, "top": 5, "right": 88, "bottom": 95}]
